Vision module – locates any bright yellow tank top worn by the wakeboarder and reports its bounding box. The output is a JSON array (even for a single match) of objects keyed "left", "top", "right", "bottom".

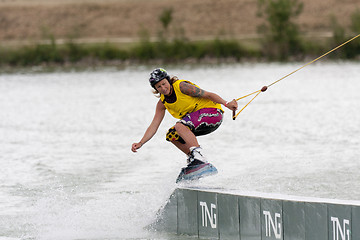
[{"left": 160, "top": 80, "right": 222, "bottom": 119}]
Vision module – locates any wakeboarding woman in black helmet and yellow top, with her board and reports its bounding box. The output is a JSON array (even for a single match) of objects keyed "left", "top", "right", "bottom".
[{"left": 131, "top": 68, "right": 238, "bottom": 182}]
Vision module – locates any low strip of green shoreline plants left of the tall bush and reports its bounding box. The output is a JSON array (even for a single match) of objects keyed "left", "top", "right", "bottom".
[{"left": 0, "top": 39, "right": 258, "bottom": 66}]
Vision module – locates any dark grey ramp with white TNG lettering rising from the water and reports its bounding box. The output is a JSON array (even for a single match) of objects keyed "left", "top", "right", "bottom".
[{"left": 152, "top": 188, "right": 360, "bottom": 240}]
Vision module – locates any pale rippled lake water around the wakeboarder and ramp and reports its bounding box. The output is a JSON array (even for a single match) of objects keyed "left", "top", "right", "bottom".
[{"left": 0, "top": 62, "right": 360, "bottom": 240}]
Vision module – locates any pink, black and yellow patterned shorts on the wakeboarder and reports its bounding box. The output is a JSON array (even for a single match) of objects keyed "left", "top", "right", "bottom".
[{"left": 166, "top": 108, "right": 223, "bottom": 143}]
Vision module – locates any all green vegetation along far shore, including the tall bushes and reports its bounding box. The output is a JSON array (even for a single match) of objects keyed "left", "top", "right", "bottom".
[{"left": 0, "top": 5, "right": 360, "bottom": 66}]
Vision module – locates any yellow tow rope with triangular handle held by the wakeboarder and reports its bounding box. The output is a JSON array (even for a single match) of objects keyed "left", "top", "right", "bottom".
[{"left": 233, "top": 34, "right": 360, "bottom": 120}]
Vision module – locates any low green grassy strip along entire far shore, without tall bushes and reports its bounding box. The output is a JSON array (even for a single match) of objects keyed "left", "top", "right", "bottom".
[{"left": 0, "top": 37, "right": 360, "bottom": 67}]
